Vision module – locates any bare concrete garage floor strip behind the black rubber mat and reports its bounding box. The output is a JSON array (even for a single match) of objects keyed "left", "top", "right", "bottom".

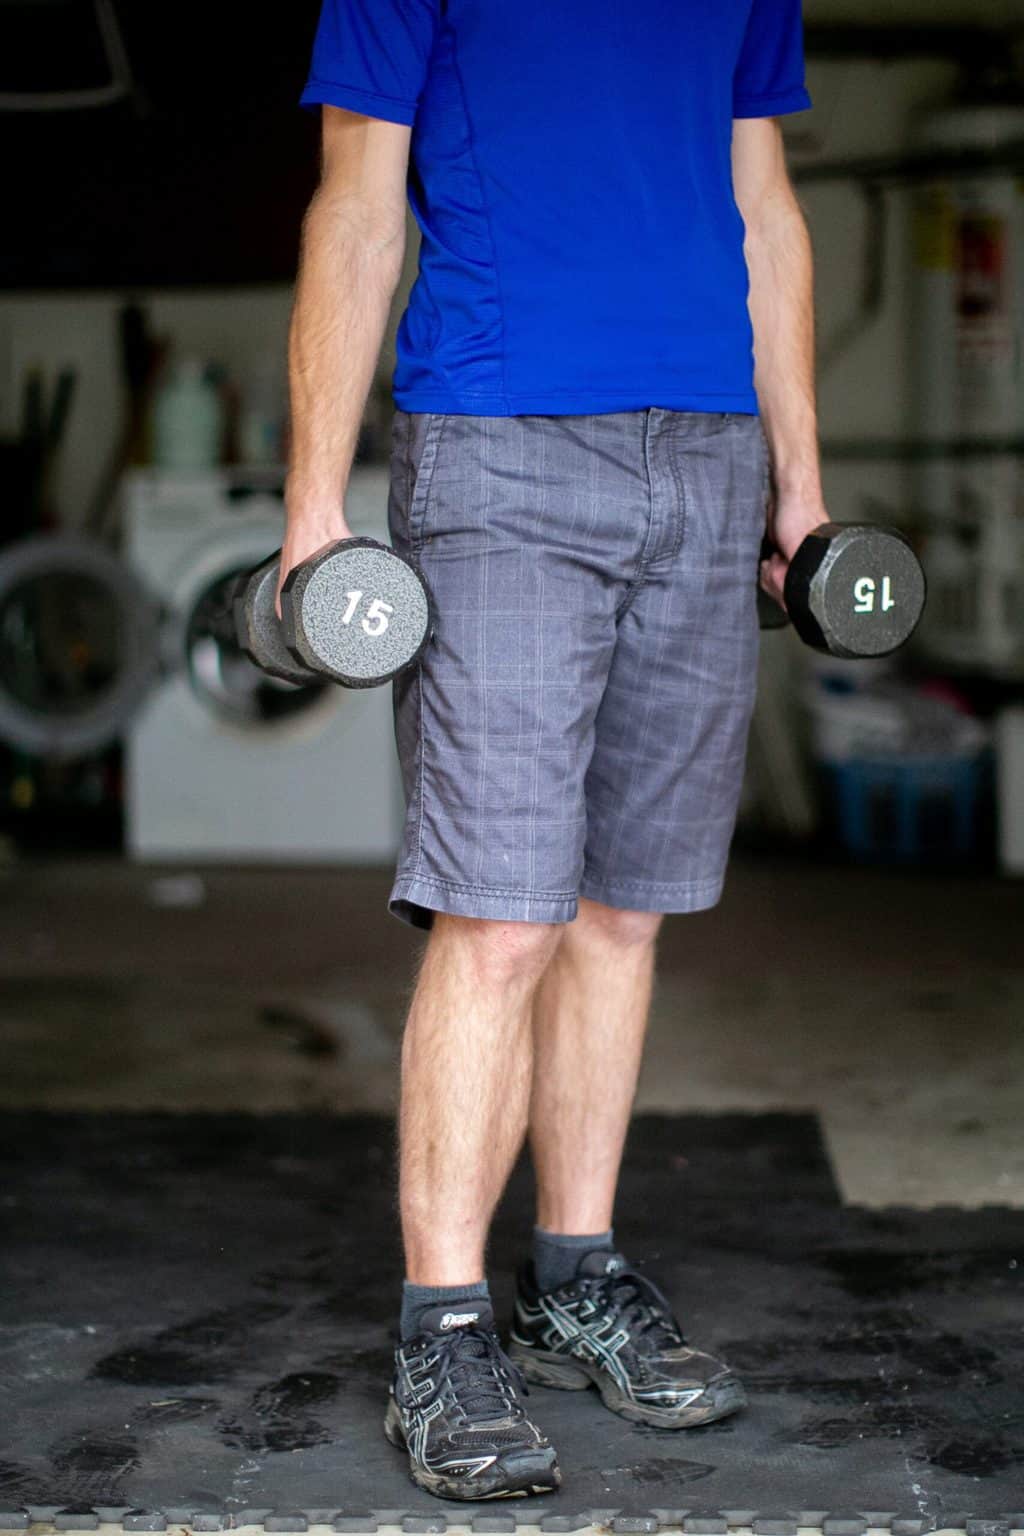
[{"left": 0, "top": 860, "right": 1024, "bottom": 1206}]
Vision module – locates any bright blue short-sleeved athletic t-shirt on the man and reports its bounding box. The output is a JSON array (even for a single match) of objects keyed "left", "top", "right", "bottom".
[{"left": 301, "top": 0, "right": 811, "bottom": 416}]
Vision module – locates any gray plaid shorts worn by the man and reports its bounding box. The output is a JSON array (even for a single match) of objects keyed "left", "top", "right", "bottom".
[{"left": 388, "top": 409, "right": 769, "bottom": 928}]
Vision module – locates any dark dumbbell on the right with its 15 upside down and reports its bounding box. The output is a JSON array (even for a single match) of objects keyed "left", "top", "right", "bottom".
[{"left": 757, "top": 522, "right": 926, "bottom": 657}]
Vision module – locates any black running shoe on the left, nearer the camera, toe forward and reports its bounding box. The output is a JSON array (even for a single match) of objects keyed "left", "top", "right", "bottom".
[{"left": 384, "top": 1301, "right": 562, "bottom": 1499}]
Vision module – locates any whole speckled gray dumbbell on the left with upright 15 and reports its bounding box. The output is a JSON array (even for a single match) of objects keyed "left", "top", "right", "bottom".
[{"left": 232, "top": 538, "right": 434, "bottom": 688}]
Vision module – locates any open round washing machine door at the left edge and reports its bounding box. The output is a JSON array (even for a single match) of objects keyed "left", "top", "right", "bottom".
[{"left": 0, "top": 533, "right": 160, "bottom": 757}]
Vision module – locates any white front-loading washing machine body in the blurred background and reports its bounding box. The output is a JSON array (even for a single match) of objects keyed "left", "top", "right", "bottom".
[{"left": 124, "top": 467, "right": 402, "bottom": 863}]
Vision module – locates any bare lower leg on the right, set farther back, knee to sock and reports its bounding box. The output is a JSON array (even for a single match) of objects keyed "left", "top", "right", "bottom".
[{"left": 530, "top": 897, "right": 662, "bottom": 1233}]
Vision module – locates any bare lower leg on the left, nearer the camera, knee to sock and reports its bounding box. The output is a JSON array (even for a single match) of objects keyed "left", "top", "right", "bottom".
[{"left": 399, "top": 912, "right": 565, "bottom": 1286}]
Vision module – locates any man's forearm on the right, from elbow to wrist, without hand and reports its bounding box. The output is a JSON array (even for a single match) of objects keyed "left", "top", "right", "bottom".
[{"left": 745, "top": 187, "right": 821, "bottom": 505}]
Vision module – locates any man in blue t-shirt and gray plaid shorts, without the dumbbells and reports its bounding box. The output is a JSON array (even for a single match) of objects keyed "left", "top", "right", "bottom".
[{"left": 282, "top": 0, "right": 826, "bottom": 1499}]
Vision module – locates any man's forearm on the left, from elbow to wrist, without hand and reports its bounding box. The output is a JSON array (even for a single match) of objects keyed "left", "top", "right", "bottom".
[{"left": 287, "top": 189, "right": 404, "bottom": 542}]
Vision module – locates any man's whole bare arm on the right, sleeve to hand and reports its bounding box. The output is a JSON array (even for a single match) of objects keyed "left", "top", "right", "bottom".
[{"left": 732, "top": 117, "right": 827, "bottom": 601}]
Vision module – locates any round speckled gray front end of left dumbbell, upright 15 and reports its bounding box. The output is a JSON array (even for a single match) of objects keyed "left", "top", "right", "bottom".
[{"left": 281, "top": 538, "right": 433, "bottom": 688}]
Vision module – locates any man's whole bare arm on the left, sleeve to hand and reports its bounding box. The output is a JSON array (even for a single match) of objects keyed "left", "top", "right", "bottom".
[{"left": 278, "top": 106, "right": 410, "bottom": 613}]
